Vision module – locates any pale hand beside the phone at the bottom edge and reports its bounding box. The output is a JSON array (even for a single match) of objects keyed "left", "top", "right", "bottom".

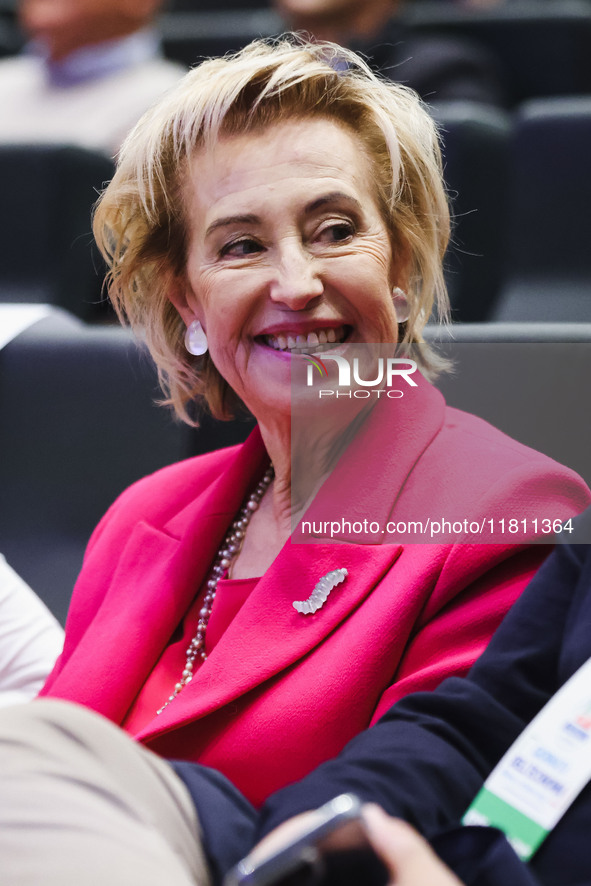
[{"left": 360, "top": 804, "right": 462, "bottom": 886}]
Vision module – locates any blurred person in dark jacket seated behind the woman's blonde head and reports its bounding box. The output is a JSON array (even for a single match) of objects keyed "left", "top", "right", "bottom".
[{"left": 274, "top": 0, "right": 503, "bottom": 105}]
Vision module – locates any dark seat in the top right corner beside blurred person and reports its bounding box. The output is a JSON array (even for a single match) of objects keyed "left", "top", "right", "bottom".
[{"left": 404, "top": 0, "right": 591, "bottom": 107}]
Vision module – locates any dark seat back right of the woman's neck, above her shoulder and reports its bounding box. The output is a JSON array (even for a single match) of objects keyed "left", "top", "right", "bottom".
[{"left": 425, "top": 323, "right": 591, "bottom": 485}]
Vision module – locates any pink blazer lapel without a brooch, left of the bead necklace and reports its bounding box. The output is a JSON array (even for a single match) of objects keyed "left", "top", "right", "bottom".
[{"left": 52, "top": 429, "right": 268, "bottom": 721}]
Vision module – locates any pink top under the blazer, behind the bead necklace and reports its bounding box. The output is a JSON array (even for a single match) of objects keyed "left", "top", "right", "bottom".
[{"left": 121, "top": 578, "right": 259, "bottom": 735}]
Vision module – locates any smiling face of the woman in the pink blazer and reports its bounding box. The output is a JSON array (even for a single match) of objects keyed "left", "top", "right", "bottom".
[{"left": 171, "top": 118, "right": 406, "bottom": 422}]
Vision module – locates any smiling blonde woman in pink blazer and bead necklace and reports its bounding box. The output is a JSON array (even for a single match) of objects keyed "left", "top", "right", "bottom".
[{"left": 44, "top": 41, "right": 589, "bottom": 804}]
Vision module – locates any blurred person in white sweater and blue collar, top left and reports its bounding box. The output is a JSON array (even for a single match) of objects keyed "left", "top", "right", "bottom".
[{"left": 0, "top": 0, "right": 185, "bottom": 155}]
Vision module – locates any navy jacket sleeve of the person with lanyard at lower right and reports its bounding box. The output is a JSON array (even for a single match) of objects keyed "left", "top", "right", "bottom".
[{"left": 225, "top": 510, "right": 591, "bottom": 886}]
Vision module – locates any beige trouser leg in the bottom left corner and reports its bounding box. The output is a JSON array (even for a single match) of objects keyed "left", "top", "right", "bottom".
[{"left": 0, "top": 700, "right": 210, "bottom": 886}]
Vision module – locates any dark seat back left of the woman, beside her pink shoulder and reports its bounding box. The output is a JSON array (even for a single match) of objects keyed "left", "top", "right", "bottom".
[{"left": 0, "top": 306, "right": 250, "bottom": 621}]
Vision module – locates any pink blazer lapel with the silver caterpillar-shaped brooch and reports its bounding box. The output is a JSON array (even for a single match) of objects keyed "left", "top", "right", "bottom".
[{"left": 137, "top": 542, "right": 401, "bottom": 740}]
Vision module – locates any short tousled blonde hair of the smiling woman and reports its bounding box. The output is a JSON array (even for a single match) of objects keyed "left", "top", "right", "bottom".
[{"left": 94, "top": 35, "right": 449, "bottom": 423}]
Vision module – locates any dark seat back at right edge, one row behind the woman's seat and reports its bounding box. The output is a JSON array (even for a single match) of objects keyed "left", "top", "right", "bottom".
[{"left": 493, "top": 99, "right": 591, "bottom": 322}]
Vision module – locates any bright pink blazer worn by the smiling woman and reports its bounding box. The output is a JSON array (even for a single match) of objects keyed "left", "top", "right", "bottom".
[{"left": 43, "top": 382, "right": 591, "bottom": 804}]
